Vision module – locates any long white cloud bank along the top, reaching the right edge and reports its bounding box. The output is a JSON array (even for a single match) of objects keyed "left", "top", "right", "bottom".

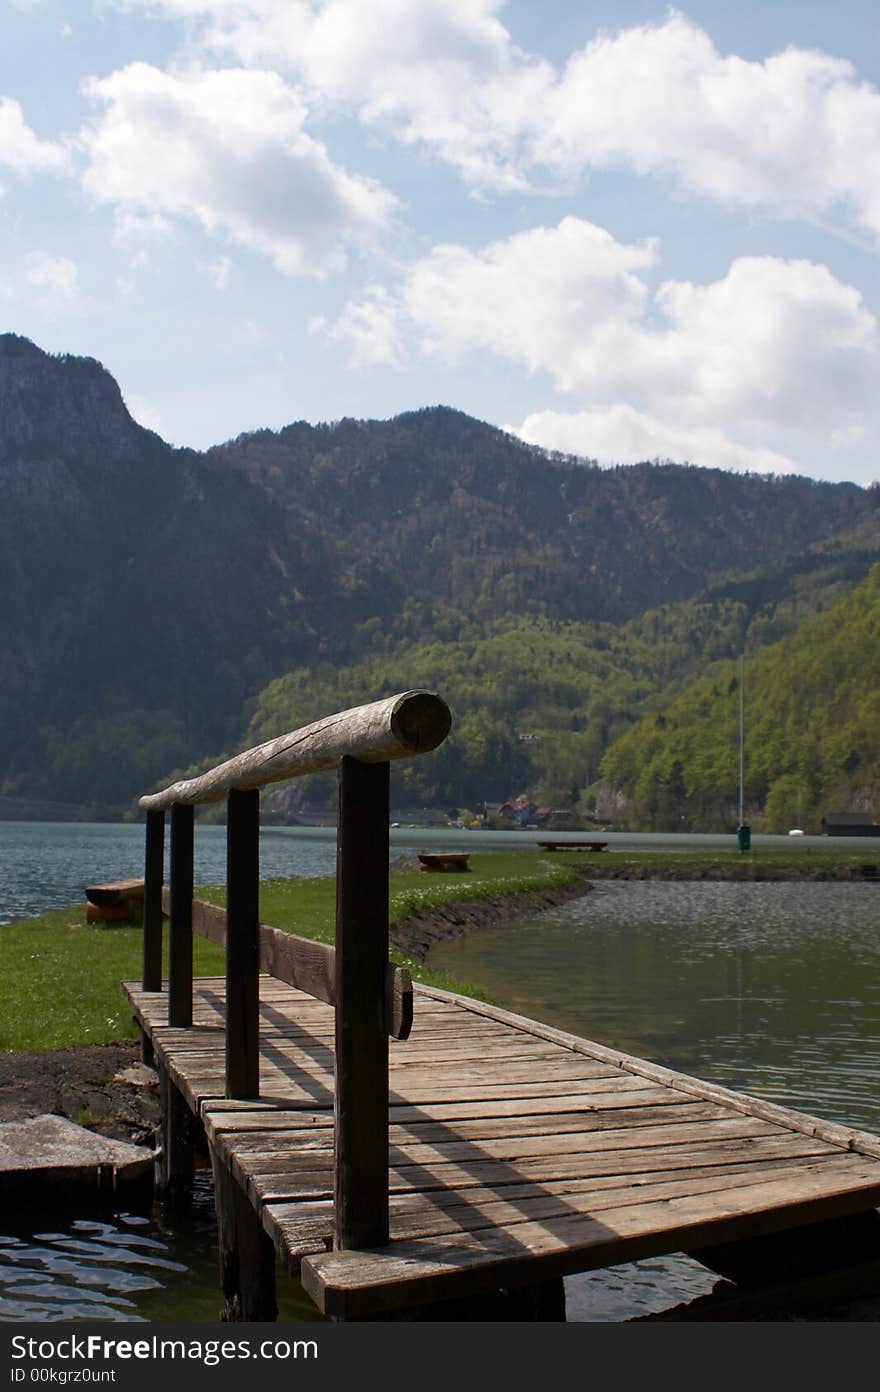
[{"left": 118, "top": 0, "right": 880, "bottom": 237}]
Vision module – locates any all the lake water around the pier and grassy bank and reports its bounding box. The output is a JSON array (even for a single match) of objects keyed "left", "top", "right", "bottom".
[{"left": 0, "top": 823, "right": 880, "bottom": 1321}]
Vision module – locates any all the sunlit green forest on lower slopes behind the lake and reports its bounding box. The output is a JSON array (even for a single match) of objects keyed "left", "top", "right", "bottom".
[{"left": 178, "top": 542, "right": 880, "bottom": 830}]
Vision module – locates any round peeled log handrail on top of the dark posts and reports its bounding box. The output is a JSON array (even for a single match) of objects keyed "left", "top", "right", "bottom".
[{"left": 138, "top": 690, "right": 453, "bottom": 812}]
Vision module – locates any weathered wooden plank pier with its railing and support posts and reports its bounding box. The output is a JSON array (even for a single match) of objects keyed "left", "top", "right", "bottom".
[{"left": 125, "top": 693, "right": 880, "bottom": 1320}]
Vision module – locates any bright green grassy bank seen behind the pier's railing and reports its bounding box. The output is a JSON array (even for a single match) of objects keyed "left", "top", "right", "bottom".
[{"left": 0, "top": 852, "right": 575, "bottom": 1051}]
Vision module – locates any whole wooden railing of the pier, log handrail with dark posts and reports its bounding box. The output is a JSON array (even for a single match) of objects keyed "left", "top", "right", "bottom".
[{"left": 141, "top": 690, "right": 451, "bottom": 1249}]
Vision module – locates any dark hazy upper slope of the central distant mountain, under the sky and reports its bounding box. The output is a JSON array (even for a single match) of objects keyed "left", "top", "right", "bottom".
[{"left": 209, "top": 408, "right": 880, "bottom": 639}]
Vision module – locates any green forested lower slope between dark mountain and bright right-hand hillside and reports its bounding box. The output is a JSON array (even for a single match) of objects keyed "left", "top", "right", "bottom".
[{"left": 213, "top": 528, "right": 880, "bottom": 821}]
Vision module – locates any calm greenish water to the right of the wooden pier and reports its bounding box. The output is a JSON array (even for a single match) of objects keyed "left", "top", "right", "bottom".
[{"left": 430, "top": 881, "right": 880, "bottom": 1321}]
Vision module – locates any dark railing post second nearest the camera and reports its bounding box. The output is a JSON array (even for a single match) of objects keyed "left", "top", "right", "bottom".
[{"left": 226, "top": 788, "right": 260, "bottom": 1097}]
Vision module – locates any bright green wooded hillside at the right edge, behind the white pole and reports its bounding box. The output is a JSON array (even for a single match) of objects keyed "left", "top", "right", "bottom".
[{"left": 602, "top": 565, "right": 880, "bottom": 831}]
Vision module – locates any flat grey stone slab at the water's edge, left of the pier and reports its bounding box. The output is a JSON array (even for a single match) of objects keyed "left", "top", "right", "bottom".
[{"left": 0, "top": 1114, "right": 153, "bottom": 1203}]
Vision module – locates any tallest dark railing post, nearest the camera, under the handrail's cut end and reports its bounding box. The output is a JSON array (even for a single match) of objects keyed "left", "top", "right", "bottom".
[{"left": 334, "top": 757, "right": 388, "bottom": 1249}]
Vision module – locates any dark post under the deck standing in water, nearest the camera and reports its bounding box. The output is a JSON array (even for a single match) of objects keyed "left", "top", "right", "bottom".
[{"left": 212, "top": 1153, "right": 278, "bottom": 1321}]
